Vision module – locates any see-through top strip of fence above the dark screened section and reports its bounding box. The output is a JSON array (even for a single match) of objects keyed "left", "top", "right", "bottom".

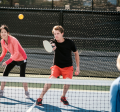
[{"left": 0, "top": 0, "right": 120, "bottom": 11}]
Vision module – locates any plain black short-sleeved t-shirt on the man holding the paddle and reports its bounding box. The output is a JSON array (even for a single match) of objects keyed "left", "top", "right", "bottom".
[{"left": 53, "top": 38, "right": 77, "bottom": 68}]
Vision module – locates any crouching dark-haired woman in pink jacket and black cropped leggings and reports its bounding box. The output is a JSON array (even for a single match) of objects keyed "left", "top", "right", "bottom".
[{"left": 0, "top": 25, "right": 29, "bottom": 98}]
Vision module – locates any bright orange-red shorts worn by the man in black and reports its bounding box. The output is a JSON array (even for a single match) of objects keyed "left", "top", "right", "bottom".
[{"left": 49, "top": 65, "right": 73, "bottom": 79}]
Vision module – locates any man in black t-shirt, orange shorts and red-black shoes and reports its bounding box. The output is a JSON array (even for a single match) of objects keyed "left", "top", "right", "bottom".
[{"left": 36, "top": 25, "right": 80, "bottom": 106}]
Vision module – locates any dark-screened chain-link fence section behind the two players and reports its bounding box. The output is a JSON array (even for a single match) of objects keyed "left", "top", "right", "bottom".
[{"left": 0, "top": 8, "right": 120, "bottom": 77}]
